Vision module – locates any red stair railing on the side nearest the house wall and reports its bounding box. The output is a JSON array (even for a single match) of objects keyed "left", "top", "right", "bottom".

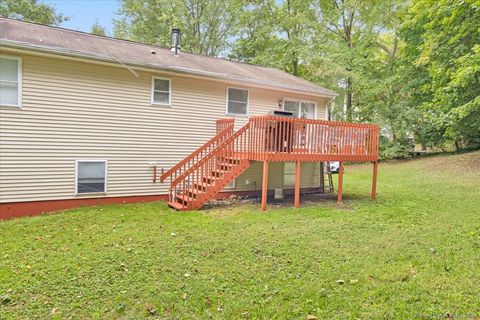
[{"left": 160, "top": 119, "right": 235, "bottom": 182}]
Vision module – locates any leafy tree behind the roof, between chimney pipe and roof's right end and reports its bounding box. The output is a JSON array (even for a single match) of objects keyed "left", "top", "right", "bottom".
[{"left": 230, "top": 0, "right": 315, "bottom": 75}]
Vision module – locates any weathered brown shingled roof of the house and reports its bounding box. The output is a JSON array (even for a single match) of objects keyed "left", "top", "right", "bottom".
[{"left": 0, "top": 18, "right": 338, "bottom": 97}]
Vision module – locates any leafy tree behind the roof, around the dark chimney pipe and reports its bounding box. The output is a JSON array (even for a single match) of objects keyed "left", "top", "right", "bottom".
[{"left": 114, "top": 0, "right": 239, "bottom": 56}]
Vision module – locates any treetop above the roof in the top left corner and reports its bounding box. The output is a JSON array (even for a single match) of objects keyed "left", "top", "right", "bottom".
[{"left": 0, "top": 0, "right": 69, "bottom": 26}]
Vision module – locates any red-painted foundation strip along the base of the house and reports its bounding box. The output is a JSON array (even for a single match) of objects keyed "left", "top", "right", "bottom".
[{"left": 0, "top": 188, "right": 318, "bottom": 220}]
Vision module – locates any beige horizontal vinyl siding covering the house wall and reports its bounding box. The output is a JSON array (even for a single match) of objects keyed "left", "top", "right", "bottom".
[{"left": 0, "top": 50, "right": 326, "bottom": 202}]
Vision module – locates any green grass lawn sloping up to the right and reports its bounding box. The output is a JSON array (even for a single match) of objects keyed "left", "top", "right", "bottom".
[{"left": 0, "top": 152, "right": 480, "bottom": 319}]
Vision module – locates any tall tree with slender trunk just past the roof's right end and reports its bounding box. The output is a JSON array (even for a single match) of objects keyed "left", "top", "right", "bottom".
[{"left": 316, "top": 0, "right": 403, "bottom": 121}]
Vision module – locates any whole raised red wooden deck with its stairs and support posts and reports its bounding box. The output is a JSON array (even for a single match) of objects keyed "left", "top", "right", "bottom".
[{"left": 158, "top": 115, "right": 379, "bottom": 210}]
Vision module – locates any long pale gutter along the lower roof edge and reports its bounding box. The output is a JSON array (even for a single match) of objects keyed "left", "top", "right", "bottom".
[{"left": 0, "top": 39, "right": 339, "bottom": 100}]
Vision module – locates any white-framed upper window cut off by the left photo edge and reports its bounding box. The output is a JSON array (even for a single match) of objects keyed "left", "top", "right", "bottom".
[{"left": 0, "top": 56, "right": 22, "bottom": 107}]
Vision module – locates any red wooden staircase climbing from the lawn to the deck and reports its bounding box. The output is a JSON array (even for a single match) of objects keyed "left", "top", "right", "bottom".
[{"left": 160, "top": 119, "right": 251, "bottom": 211}]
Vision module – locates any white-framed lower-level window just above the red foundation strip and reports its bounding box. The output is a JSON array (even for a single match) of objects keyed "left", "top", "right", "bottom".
[{"left": 75, "top": 160, "right": 107, "bottom": 194}]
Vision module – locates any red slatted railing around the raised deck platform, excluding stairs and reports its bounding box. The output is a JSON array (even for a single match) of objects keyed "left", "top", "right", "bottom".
[{"left": 248, "top": 116, "right": 379, "bottom": 161}]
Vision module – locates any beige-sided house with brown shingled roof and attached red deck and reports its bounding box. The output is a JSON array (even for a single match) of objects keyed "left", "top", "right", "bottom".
[{"left": 0, "top": 19, "right": 378, "bottom": 218}]
